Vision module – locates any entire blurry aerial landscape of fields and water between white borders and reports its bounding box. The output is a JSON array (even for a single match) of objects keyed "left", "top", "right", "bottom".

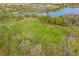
[{"left": 0, "top": 3, "right": 79, "bottom": 56}]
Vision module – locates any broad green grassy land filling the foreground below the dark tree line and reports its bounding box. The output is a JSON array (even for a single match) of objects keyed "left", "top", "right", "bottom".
[{"left": 0, "top": 18, "right": 79, "bottom": 55}]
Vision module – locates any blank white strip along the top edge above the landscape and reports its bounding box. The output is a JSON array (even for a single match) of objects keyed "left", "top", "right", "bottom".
[{"left": 0, "top": 0, "right": 79, "bottom": 3}]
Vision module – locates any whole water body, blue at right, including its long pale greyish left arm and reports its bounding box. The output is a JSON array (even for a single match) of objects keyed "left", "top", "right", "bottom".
[{"left": 14, "top": 8, "right": 79, "bottom": 17}]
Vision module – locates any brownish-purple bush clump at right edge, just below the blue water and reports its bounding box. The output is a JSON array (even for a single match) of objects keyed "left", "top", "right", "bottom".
[{"left": 60, "top": 15, "right": 79, "bottom": 26}]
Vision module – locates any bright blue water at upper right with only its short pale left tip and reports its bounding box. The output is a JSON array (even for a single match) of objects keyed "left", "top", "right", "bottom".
[{"left": 37, "top": 8, "right": 79, "bottom": 17}]
